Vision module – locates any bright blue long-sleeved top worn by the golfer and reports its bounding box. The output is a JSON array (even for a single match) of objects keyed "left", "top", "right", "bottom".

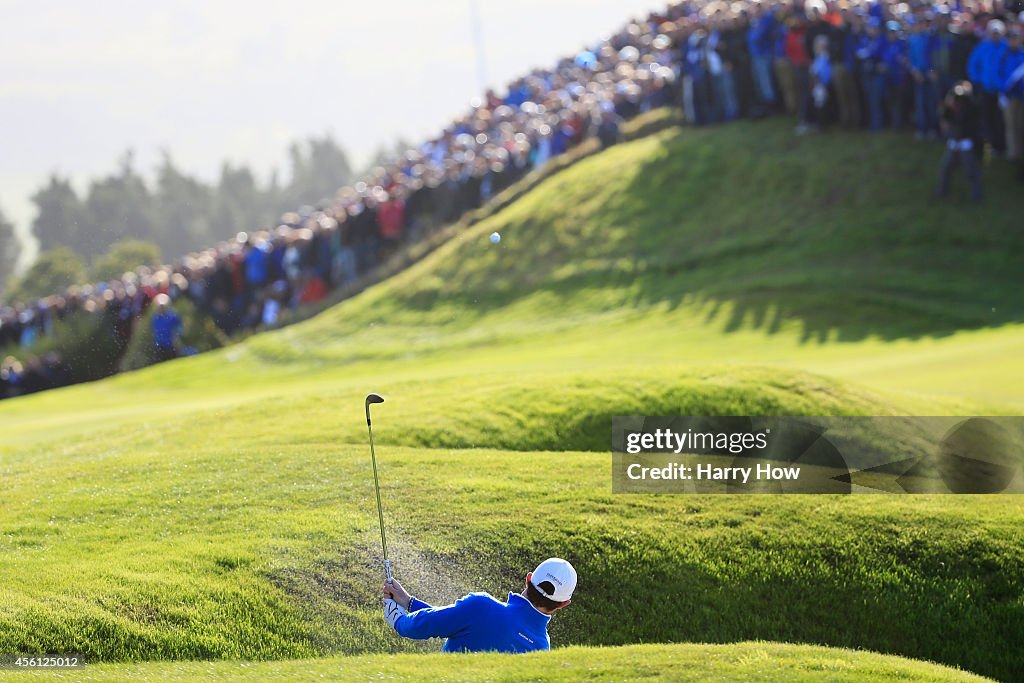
[{"left": 394, "top": 593, "right": 551, "bottom": 652}]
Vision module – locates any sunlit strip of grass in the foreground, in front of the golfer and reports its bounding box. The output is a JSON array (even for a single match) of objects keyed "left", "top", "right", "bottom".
[{"left": 0, "top": 642, "right": 989, "bottom": 683}]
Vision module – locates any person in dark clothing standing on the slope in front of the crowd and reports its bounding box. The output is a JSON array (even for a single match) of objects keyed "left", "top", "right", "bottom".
[{"left": 936, "top": 81, "right": 981, "bottom": 202}]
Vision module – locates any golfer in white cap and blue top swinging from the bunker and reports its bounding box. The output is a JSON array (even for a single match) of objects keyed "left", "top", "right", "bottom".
[{"left": 384, "top": 557, "right": 577, "bottom": 652}]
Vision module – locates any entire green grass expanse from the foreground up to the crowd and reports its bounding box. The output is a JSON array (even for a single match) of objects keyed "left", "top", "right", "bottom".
[{"left": 0, "top": 111, "right": 1024, "bottom": 680}]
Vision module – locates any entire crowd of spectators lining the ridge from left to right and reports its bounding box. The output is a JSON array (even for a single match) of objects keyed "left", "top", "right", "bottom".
[{"left": 0, "top": 0, "right": 1024, "bottom": 398}]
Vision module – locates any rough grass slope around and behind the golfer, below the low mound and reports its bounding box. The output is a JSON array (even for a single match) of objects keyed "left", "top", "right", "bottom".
[{"left": 0, "top": 440, "right": 1024, "bottom": 678}]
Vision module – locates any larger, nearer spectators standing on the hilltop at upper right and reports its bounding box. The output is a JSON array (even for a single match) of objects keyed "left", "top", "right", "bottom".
[{"left": 676, "top": 0, "right": 1024, "bottom": 147}]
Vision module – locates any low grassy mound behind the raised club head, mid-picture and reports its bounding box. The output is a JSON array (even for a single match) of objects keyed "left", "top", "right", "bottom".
[{"left": 68, "top": 366, "right": 962, "bottom": 453}]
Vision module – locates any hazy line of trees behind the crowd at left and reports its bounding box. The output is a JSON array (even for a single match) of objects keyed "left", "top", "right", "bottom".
[{"left": 0, "top": 134, "right": 353, "bottom": 299}]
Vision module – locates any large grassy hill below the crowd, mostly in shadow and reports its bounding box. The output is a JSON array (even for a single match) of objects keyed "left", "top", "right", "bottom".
[{"left": 258, "top": 115, "right": 1024, "bottom": 352}]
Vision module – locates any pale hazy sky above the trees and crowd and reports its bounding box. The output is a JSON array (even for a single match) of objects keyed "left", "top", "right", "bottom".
[{"left": 0, "top": 0, "right": 667, "bottom": 266}]
